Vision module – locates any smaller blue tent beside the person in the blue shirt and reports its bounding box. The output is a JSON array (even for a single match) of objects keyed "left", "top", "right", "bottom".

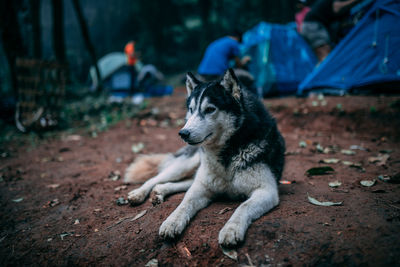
[{"left": 241, "top": 22, "right": 317, "bottom": 96}]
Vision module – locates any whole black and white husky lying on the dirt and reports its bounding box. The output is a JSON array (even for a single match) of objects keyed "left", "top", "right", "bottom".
[{"left": 125, "top": 69, "right": 285, "bottom": 246}]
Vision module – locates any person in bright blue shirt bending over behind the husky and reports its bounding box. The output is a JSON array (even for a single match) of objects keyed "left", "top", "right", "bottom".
[{"left": 197, "top": 30, "right": 250, "bottom": 81}]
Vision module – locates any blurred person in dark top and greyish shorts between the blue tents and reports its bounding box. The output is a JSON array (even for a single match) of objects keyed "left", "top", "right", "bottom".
[{"left": 301, "top": 0, "right": 359, "bottom": 62}]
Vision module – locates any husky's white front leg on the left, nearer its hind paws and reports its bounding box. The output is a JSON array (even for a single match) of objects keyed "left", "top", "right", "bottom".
[{"left": 159, "top": 180, "right": 211, "bottom": 239}]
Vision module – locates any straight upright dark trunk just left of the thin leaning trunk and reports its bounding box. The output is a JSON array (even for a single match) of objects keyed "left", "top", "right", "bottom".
[{"left": 51, "top": 0, "right": 66, "bottom": 63}]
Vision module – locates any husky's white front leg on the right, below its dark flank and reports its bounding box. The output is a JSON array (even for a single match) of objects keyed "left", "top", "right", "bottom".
[{"left": 218, "top": 186, "right": 279, "bottom": 247}]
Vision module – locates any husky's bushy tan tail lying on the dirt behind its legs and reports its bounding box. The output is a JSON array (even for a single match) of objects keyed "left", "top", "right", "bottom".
[{"left": 124, "top": 154, "right": 171, "bottom": 184}]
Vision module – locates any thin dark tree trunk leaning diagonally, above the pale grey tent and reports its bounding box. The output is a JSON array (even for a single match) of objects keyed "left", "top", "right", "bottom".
[{"left": 72, "top": 0, "right": 102, "bottom": 91}]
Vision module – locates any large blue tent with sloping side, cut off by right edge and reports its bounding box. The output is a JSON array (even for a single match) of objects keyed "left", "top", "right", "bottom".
[{"left": 298, "top": 0, "right": 400, "bottom": 95}]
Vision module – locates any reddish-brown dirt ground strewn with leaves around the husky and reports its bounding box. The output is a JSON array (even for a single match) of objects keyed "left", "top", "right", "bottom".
[{"left": 0, "top": 88, "right": 400, "bottom": 266}]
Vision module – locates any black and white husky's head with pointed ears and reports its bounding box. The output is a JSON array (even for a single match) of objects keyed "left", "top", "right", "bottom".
[{"left": 179, "top": 69, "right": 243, "bottom": 149}]
